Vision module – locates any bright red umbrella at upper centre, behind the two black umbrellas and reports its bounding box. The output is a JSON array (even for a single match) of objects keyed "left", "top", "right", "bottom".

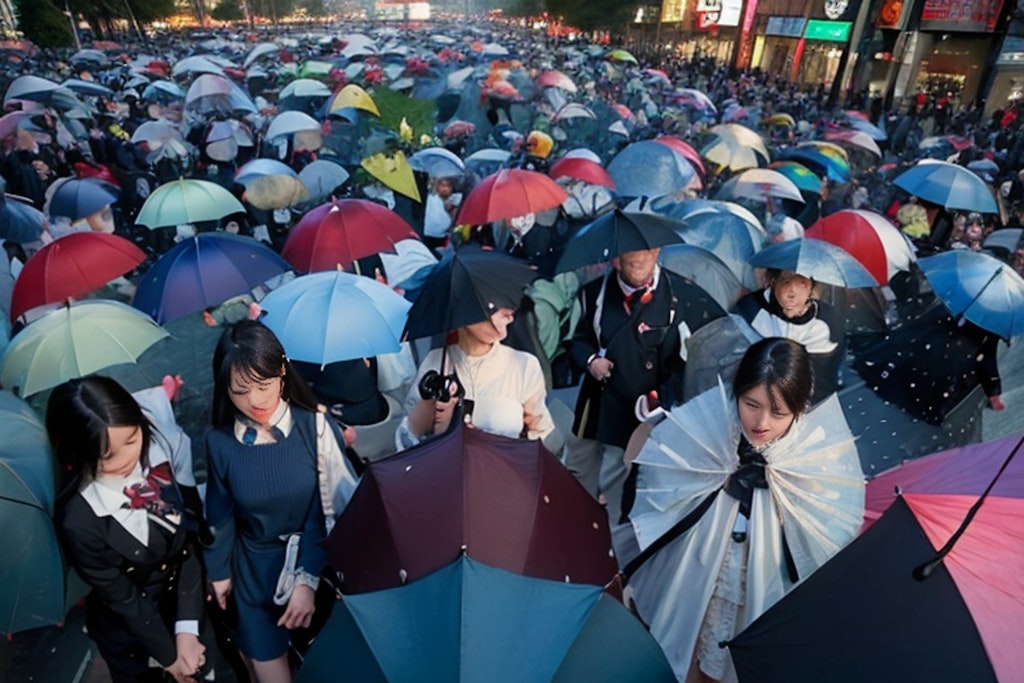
[{"left": 456, "top": 168, "right": 568, "bottom": 225}]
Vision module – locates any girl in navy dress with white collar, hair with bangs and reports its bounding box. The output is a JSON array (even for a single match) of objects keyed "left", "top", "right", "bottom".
[{"left": 206, "top": 321, "right": 356, "bottom": 683}]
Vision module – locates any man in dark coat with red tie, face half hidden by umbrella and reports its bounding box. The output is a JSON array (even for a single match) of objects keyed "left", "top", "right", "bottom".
[{"left": 570, "top": 249, "right": 725, "bottom": 516}]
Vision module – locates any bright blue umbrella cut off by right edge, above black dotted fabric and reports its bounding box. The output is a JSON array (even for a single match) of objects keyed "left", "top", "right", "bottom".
[{"left": 918, "top": 249, "right": 1024, "bottom": 340}]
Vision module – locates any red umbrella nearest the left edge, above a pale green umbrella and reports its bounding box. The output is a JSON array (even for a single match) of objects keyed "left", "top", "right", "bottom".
[{"left": 10, "top": 232, "right": 145, "bottom": 321}]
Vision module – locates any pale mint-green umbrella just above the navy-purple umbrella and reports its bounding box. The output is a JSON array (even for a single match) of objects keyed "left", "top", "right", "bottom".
[{"left": 135, "top": 178, "right": 246, "bottom": 229}]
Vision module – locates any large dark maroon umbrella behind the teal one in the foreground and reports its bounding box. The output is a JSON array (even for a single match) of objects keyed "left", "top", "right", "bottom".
[{"left": 327, "top": 425, "right": 617, "bottom": 594}]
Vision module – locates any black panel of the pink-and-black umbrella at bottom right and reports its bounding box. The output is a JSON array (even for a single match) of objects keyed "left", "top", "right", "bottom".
[{"left": 728, "top": 497, "right": 1009, "bottom": 683}]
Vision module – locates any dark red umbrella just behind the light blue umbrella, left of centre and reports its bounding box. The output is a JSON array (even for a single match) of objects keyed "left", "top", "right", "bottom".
[{"left": 281, "top": 200, "right": 417, "bottom": 272}]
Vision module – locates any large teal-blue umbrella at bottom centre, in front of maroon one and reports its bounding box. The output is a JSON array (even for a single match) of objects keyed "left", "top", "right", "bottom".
[{"left": 296, "top": 555, "right": 675, "bottom": 683}]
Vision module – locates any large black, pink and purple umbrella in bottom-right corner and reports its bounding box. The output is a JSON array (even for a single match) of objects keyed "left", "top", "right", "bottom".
[{"left": 729, "top": 435, "right": 1024, "bottom": 681}]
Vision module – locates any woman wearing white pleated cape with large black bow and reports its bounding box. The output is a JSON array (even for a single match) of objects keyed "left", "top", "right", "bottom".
[{"left": 624, "top": 338, "right": 864, "bottom": 681}]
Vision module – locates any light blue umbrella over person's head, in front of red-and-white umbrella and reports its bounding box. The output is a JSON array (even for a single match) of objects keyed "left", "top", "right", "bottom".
[{"left": 751, "top": 238, "right": 881, "bottom": 287}]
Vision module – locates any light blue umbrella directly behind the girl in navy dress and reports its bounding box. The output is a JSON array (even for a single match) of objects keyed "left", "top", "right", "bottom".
[{"left": 260, "top": 270, "right": 412, "bottom": 366}]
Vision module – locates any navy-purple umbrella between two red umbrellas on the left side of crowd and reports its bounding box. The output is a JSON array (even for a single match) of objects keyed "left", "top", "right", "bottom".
[{"left": 132, "top": 232, "right": 291, "bottom": 323}]
